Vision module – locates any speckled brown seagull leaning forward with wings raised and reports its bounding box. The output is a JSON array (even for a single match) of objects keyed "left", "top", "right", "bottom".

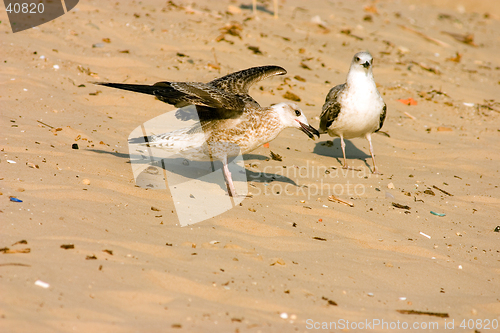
[{"left": 95, "top": 66, "right": 319, "bottom": 197}]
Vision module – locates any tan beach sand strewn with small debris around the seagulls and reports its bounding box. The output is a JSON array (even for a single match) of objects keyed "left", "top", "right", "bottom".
[{"left": 0, "top": 0, "right": 500, "bottom": 332}]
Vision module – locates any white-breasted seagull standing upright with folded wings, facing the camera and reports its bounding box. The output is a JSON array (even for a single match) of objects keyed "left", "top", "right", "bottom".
[{"left": 319, "top": 51, "right": 387, "bottom": 173}]
